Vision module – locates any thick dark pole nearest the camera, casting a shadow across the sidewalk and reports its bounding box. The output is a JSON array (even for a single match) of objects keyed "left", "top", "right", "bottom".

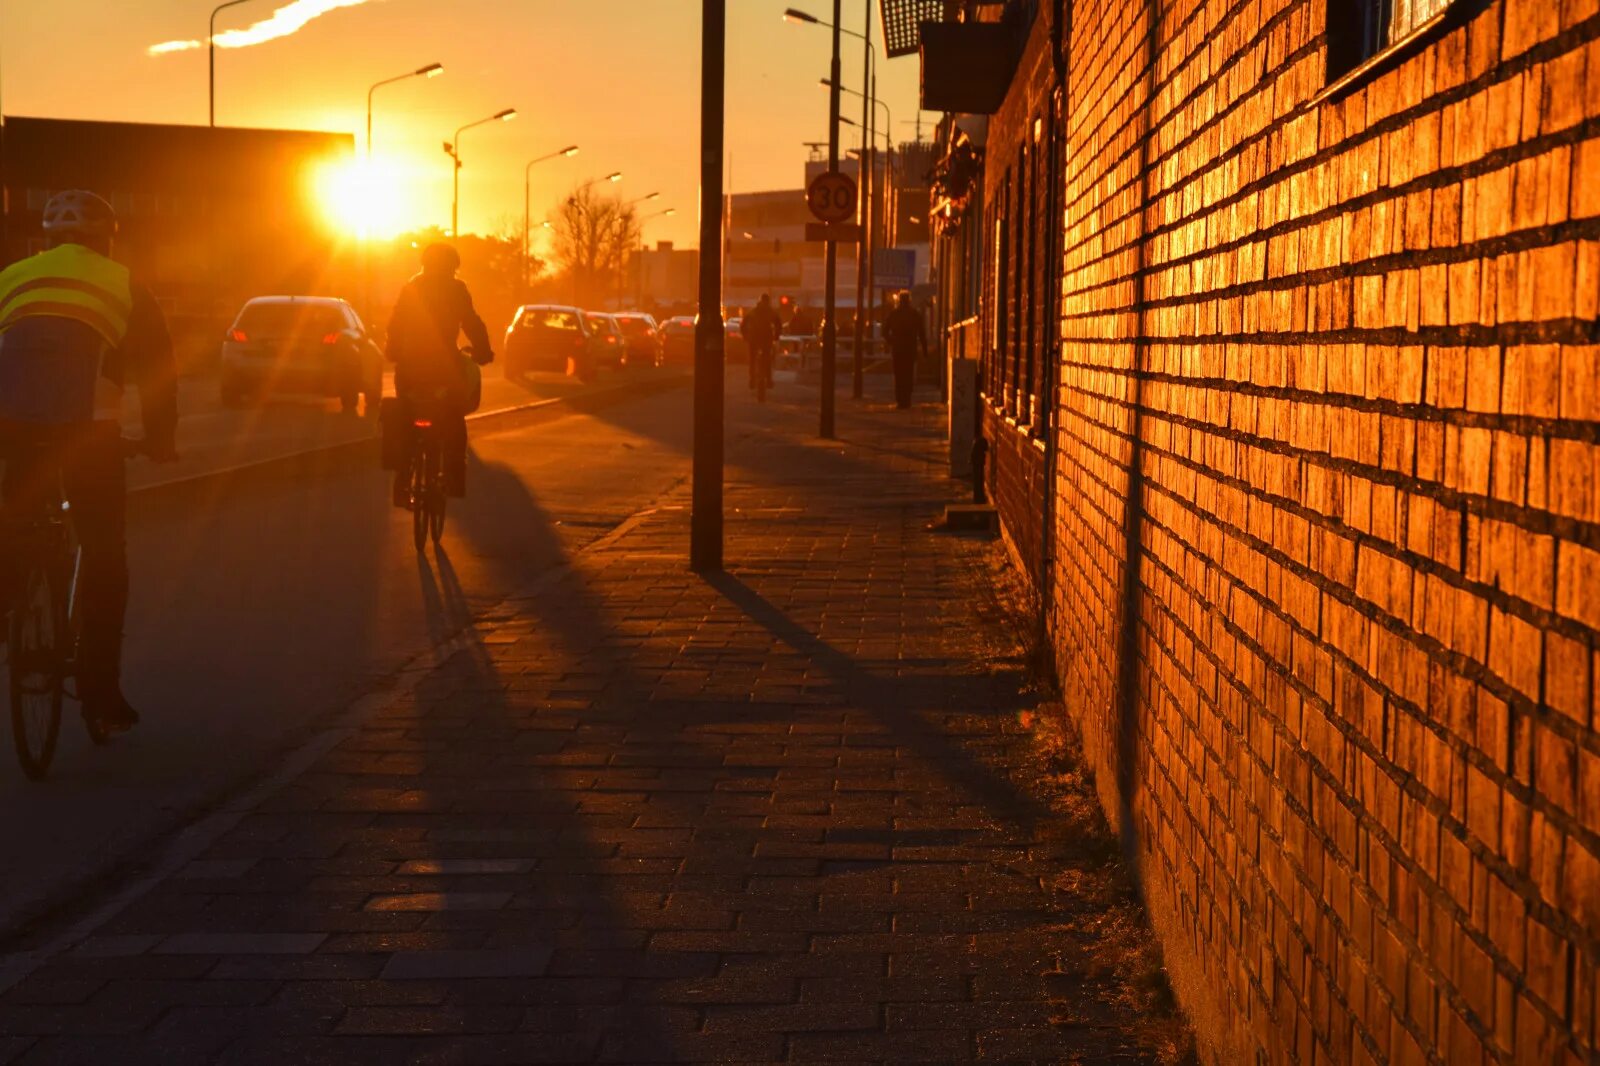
[{"left": 690, "top": 0, "right": 732, "bottom": 573}]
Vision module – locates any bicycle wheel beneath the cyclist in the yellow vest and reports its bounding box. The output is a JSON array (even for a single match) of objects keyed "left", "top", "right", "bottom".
[{"left": 6, "top": 567, "right": 66, "bottom": 781}]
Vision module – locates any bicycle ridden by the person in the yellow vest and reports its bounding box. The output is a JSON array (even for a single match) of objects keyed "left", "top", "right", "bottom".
[{"left": 5, "top": 440, "right": 142, "bottom": 781}]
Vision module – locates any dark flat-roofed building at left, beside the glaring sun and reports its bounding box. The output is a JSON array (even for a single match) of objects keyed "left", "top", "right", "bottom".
[{"left": 0, "top": 117, "right": 358, "bottom": 365}]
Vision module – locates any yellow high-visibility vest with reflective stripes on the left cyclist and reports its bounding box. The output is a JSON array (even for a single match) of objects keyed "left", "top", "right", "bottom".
[{"left": 0, "top": 245, "right": 133, "bottom": 347}]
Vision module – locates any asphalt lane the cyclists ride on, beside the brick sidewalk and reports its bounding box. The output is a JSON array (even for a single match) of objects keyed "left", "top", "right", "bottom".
[{"left": 0, "top": 369, "right": 700, "bottom": 932}]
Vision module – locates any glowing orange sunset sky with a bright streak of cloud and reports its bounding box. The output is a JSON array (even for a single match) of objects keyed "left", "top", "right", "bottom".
[{"left": 0, "top": 0, "right": 934, "bottom": 245}]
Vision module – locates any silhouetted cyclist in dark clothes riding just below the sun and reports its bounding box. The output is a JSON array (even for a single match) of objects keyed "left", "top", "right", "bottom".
[{"left": 386, "top": 242, "right": 494, "bottom": 507}]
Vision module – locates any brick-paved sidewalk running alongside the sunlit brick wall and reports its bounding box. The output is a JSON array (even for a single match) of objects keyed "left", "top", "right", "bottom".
[{"left": 0, "top": 392, "right": 1184, "bottom": 1064}]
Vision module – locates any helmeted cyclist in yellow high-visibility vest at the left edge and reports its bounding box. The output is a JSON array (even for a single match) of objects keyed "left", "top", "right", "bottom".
[{"left": 0, "top": 189, "right": 178, "bottom": 728}]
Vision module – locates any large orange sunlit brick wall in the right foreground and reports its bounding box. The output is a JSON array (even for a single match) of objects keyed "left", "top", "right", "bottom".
[{"left": 1053, "top": 0, "right": 1600, "bottom": 1066}]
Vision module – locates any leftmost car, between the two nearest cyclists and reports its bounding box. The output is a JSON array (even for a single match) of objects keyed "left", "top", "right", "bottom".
[{"left": 219, "top": 296, "right": 384, "bottom": 416}]
